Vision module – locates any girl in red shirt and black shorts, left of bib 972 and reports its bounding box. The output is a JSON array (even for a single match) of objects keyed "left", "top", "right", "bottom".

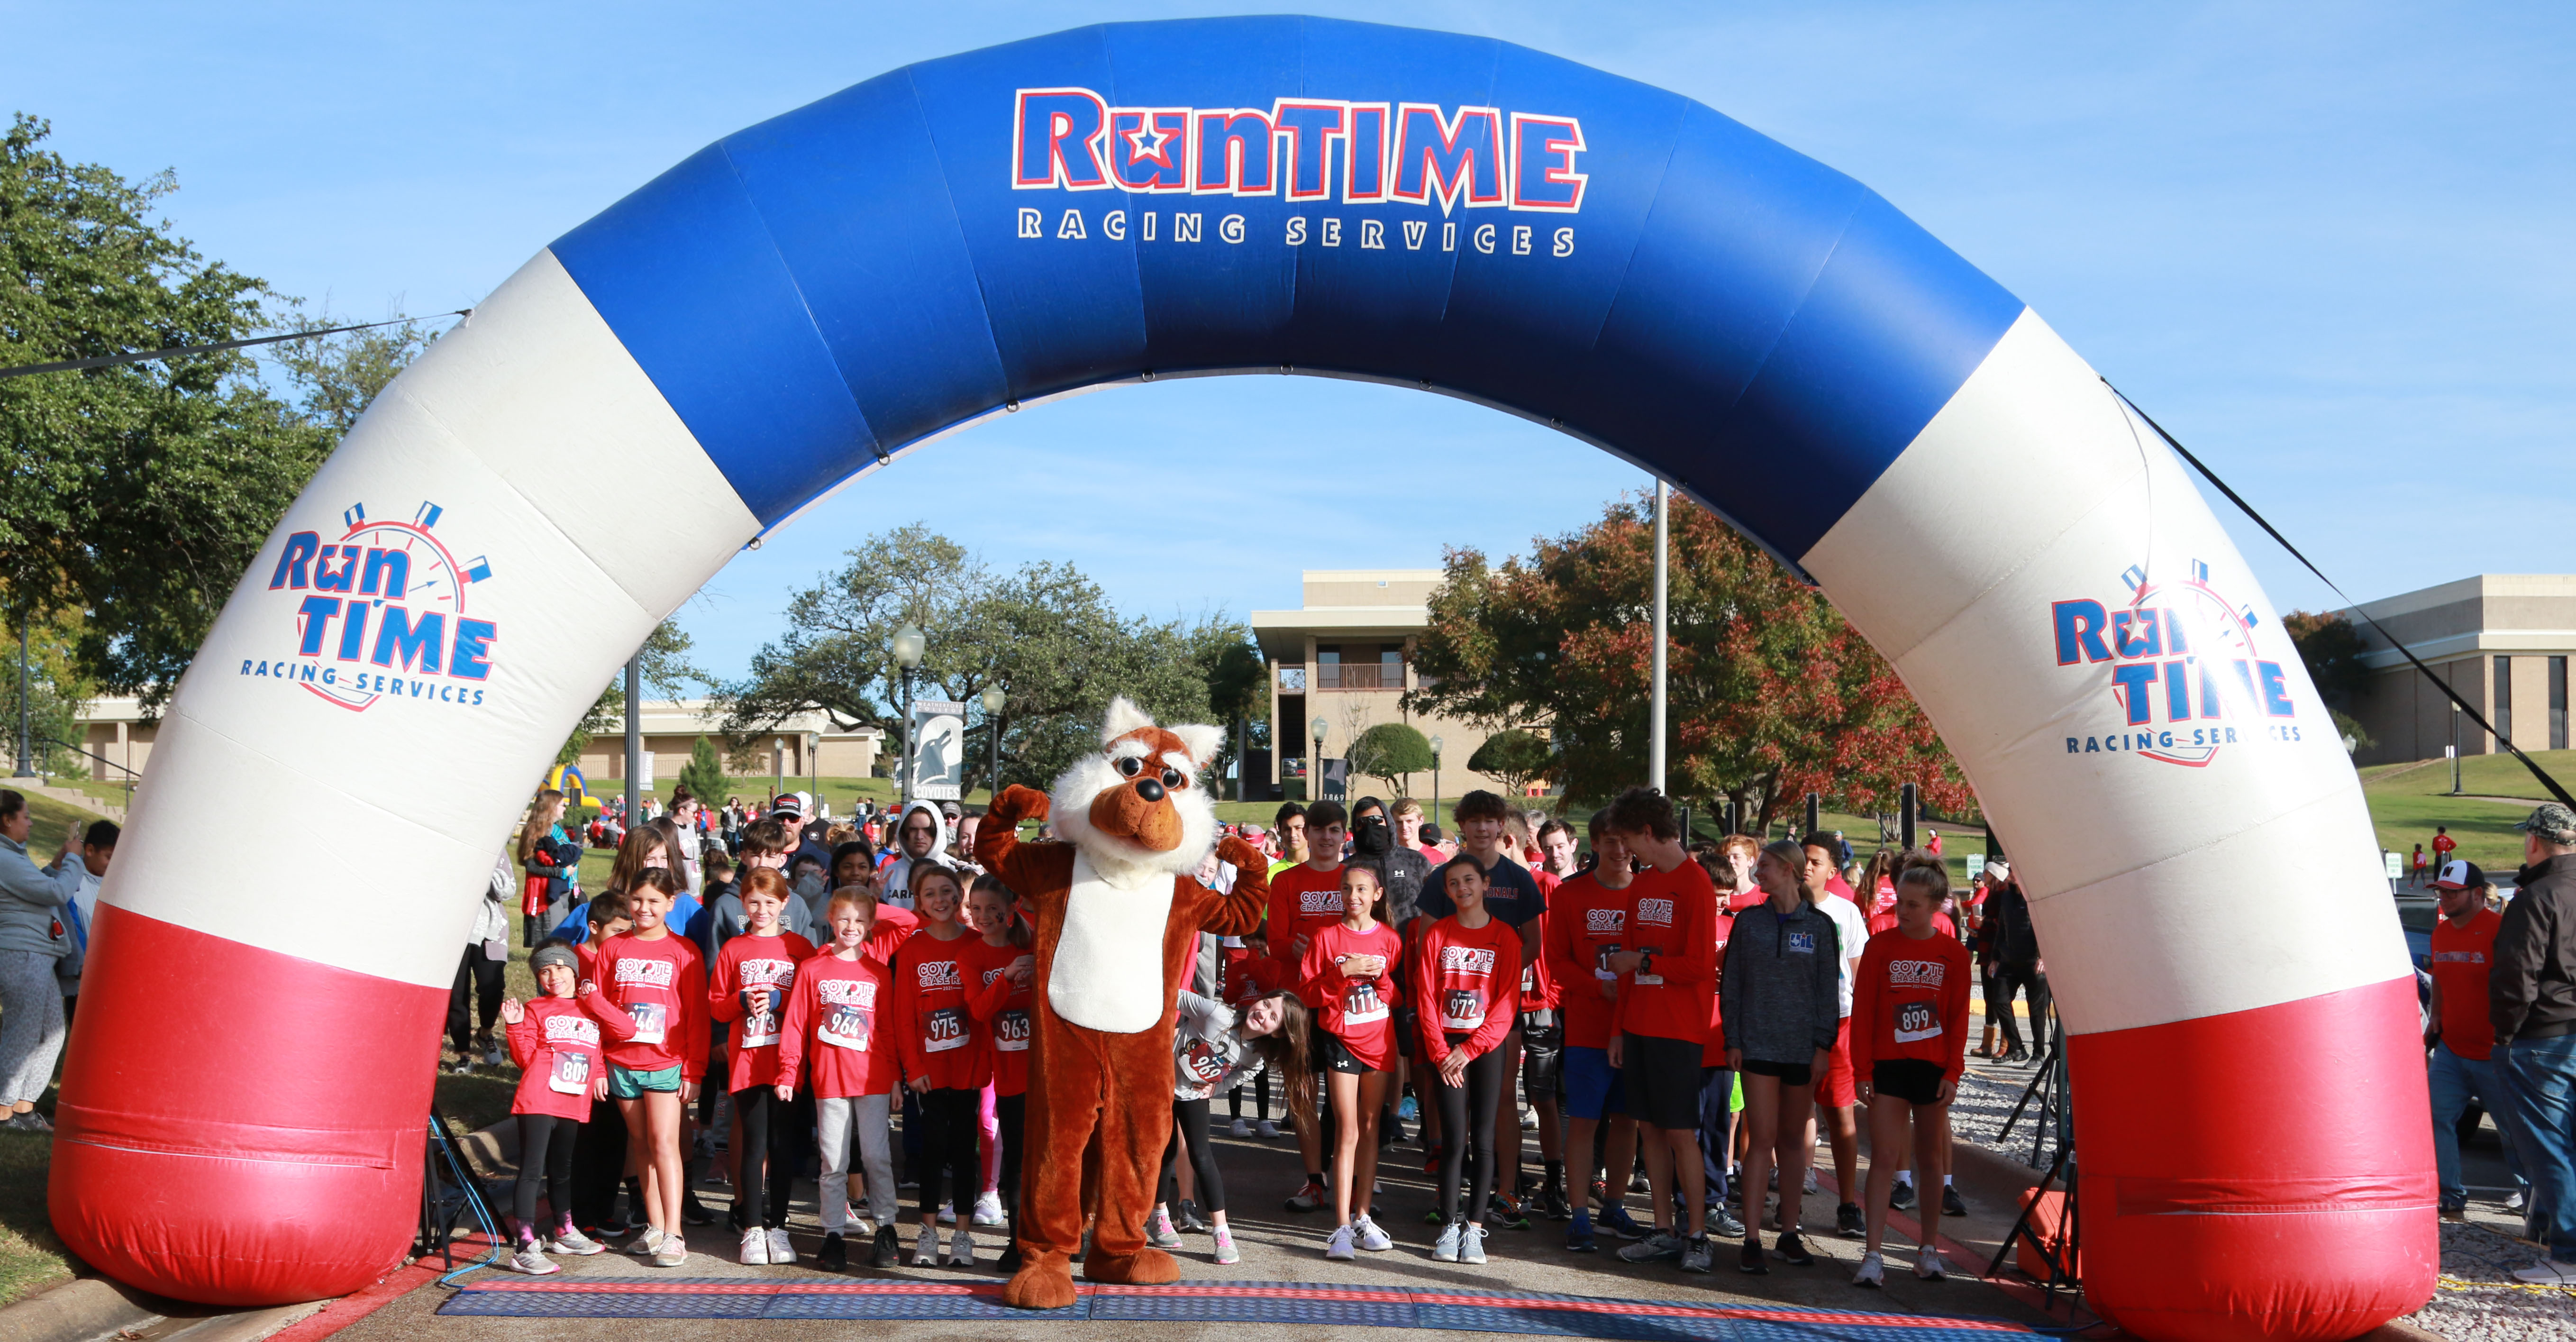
[{"left": 1298, "top": 860, "right": 1404, "bottom": 1262}]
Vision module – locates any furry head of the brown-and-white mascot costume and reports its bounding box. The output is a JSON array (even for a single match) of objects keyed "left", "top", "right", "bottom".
[{"left": 1048, "top": 695, "right": 1226, "bottom": 876}]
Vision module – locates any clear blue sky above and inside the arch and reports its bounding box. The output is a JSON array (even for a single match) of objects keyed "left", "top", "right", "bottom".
[{"left": 0, "top": 0, "right": 2576, "bottom": 672}]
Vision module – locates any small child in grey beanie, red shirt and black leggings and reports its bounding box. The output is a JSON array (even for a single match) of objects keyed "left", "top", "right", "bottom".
[{"left": 500, "top": 938, "right": 636, "bottom": 1278}]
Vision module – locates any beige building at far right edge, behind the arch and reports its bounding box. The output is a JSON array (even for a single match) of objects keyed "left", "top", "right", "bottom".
[{"left": 2347, "top": 575, "right": 2576, "bottom": 765}]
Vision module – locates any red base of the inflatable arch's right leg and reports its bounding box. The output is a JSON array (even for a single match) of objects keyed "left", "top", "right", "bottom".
[{"left": 2066, "top": 979, "right": 2442, "bottom": 1342}]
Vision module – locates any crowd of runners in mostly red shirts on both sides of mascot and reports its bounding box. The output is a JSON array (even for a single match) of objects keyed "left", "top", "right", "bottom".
[{"left": 451, "top": 788, "right": 2048, "bottom": 1285}]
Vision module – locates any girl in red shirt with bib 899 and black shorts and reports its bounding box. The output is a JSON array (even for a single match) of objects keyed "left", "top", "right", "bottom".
[{"left": 1852, "top": 863, "right": 1971, "bottom": 1285}]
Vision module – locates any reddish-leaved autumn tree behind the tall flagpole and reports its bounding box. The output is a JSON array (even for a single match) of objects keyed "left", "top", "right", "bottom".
[{"left": 1409, "top": 497, "right": 1976, "bottom": 827}]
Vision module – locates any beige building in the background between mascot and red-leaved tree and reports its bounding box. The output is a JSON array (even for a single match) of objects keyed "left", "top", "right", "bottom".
[{"left": 1249, "top": 569, "right": 1502, "bottom": 803}]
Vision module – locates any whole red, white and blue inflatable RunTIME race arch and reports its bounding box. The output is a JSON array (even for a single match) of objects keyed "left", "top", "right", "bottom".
[{"left": 52, "top": 18, "right": 2437, "bottom": 1340}]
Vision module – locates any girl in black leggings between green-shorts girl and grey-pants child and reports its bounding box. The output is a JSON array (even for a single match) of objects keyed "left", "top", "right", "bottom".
[{"left": 706, "top": 866, "right": 814, "bottom": 1265}]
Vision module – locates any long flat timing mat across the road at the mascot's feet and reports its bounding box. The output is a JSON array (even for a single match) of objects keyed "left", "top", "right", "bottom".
[{"left": 438, "top": 1278, "right": 2038, "bottom": 1342}]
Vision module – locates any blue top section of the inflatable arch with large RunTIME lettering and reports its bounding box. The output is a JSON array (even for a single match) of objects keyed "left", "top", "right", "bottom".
[{"left": 554, "top": 18, "right": 2022, "bottom": 557}]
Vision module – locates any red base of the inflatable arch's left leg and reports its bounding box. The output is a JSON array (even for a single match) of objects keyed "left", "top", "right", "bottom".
[{"left": 49, "top": 904, "right": 437, "bottom": 1306}]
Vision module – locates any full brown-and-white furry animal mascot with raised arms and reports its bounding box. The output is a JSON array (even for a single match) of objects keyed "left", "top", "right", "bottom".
[{"left": 974, "top": 698, "right": 1270, "bottom": 1308}]
